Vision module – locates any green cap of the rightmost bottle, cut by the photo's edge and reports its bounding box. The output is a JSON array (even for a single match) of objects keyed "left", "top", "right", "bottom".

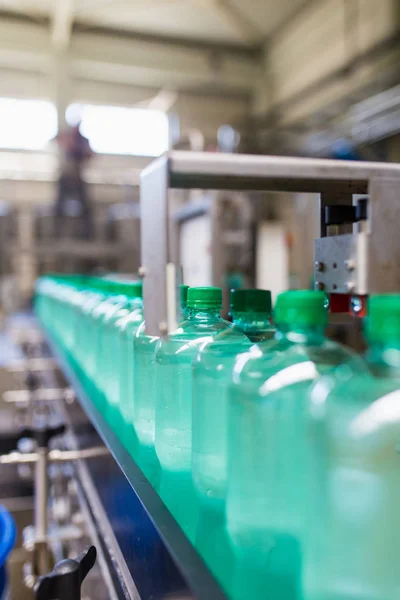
[{"left": 366, "top": 294, "right": 400, "bottom": 343}]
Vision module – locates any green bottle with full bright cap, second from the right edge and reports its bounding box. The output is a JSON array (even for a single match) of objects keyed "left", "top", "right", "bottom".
[{"left": 226, "top": 291, "right": 361, "bottom": 600}]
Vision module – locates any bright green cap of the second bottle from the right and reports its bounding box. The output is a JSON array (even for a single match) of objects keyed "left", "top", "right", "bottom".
[{"left": 274, "top": 290, "right": 328, "bottom": 327}]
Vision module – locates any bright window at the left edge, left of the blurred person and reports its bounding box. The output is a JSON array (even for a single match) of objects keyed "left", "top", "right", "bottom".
[{"left": 0, "top": 98, "right": 57, "bottom": 150}]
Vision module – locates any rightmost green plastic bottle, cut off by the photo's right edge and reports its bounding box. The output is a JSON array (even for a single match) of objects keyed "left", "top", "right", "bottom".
[{"left": 304, "top": 294, "right": 400, "bottom": 600}]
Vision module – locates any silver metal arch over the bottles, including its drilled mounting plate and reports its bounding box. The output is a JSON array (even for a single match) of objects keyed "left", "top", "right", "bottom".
[{"left": 140, "top": 152, "right": 400, "bottom": 335}]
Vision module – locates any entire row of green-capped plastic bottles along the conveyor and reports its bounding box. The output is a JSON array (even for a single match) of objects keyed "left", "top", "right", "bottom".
[{"left": 36, "top": 276, "right": 400, "bottom": 600}]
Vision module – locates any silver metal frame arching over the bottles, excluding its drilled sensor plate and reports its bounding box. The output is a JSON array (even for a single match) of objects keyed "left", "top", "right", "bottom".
[{"left": 140, "top": 152, "right": 400, "bottom": 336}]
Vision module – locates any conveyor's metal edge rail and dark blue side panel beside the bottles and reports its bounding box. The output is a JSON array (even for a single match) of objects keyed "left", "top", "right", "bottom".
[{"left": 47, "top": 336, "right": 225, "bottom": 600}]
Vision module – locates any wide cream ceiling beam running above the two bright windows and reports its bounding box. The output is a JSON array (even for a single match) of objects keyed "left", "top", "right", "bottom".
[{"left": 0, "top": 19, "right": 261, "bottom": 94}]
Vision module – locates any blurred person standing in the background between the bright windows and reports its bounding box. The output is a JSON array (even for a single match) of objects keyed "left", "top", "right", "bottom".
[{"left": 55, "top": 123, "right": 93, "bottom": 239}]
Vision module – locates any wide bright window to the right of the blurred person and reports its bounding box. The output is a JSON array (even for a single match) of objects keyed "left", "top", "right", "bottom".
[{"left": 66, "top": 104, "right": 169, "bottom": 156}]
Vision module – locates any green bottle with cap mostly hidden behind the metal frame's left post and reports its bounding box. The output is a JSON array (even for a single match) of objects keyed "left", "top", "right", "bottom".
[{"left": 130, "top": 285, "right": 189, "bottom": 484}]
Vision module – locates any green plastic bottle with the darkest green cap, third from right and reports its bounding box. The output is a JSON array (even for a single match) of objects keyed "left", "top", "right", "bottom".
[{"left": 192, "top": 290, "right": 275, "bottom": 586}]
